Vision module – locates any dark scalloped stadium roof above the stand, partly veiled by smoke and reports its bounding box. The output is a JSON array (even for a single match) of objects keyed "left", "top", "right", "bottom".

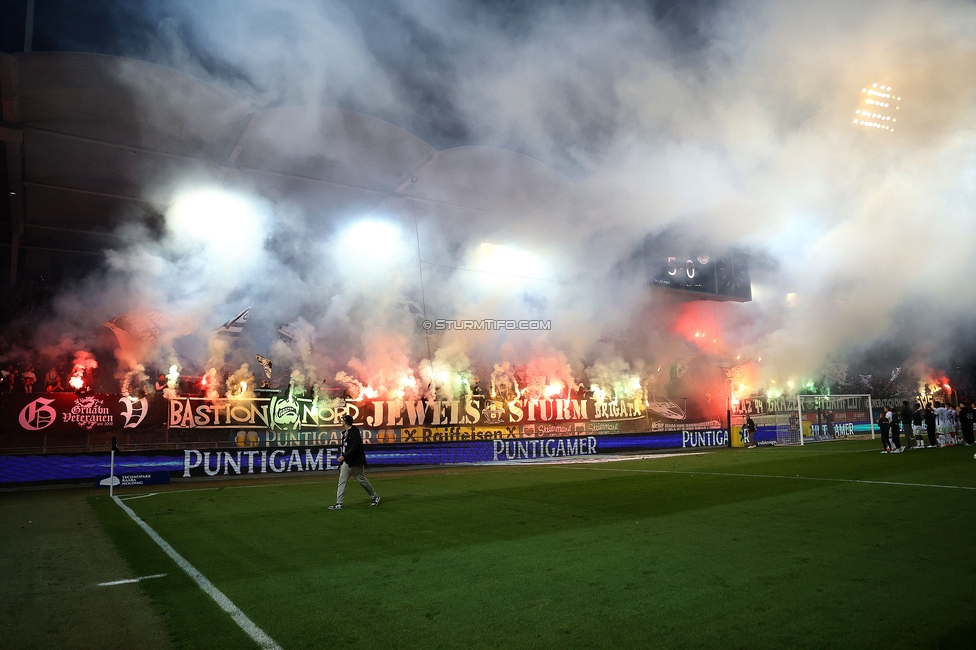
[{"left": 0, "top": 52, "right": 569, "bottom": 284}]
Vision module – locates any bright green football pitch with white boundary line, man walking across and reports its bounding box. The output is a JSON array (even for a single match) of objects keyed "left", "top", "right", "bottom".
[{"left": 2, "top": 441, "right": 976, "bottom": 650}]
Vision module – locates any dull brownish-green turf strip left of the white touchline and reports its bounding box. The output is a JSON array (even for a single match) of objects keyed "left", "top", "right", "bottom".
[{"left": 0, "top": 489, "right": 172, "bottom": 650}]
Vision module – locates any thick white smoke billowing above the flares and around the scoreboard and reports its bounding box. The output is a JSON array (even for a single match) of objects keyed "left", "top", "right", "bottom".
[{"left": 19, "top": 0, "right": 976, "bottom": 396}]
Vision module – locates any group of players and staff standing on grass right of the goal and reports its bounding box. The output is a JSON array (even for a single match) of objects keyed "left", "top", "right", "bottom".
[{"left": 877, "top": 399, "right": 976, "bottom": 454}]
